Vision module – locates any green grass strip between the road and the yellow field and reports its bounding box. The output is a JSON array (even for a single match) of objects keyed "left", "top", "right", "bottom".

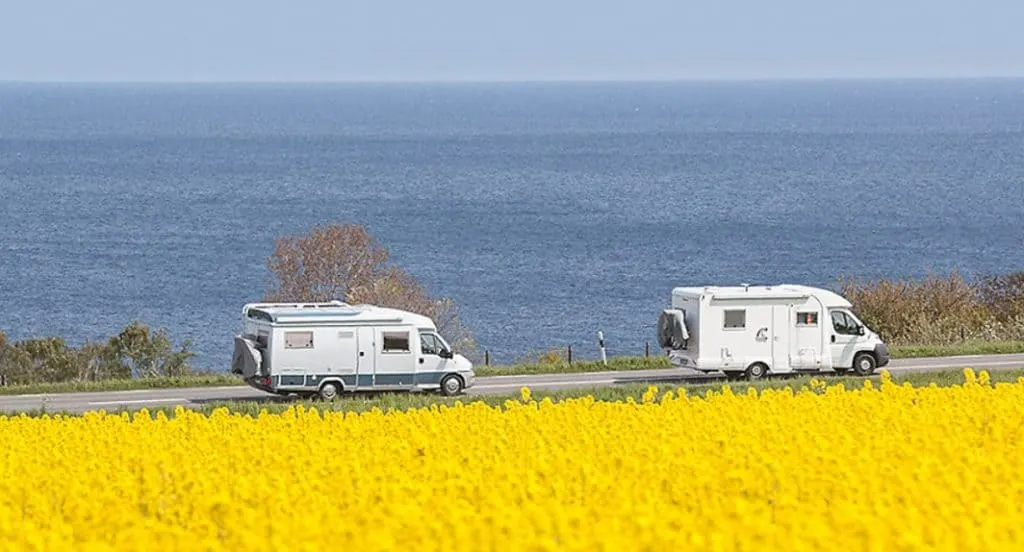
[{"left": 9, "top": 368, "right": 1024, "bottom": 418}]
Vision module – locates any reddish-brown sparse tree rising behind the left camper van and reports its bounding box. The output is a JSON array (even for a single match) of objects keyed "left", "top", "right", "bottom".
[{"left": 264, "top": 223, "right": 476, "bottom": 356}]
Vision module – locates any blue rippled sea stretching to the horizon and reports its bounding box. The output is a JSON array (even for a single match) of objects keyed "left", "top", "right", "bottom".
[{"left": 0, "top": 80, "right": 1024, "bottom": 370}]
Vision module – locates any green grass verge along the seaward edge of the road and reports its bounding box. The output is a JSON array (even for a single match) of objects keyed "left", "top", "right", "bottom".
[{"left": 0, "top": 341, "right": 1024, "bottom": 395}]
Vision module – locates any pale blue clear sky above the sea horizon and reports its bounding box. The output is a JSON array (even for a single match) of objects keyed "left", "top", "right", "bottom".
[{"left": 0, "top": 0, "right": 1024, "bottom": 82}]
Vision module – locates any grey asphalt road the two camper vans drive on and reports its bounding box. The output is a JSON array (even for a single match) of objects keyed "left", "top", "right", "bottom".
[{"left": 0, "top": 354, "right": 1024, "bottom": 413}]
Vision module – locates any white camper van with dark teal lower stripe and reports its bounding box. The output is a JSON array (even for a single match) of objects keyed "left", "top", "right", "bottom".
[{"left": 231, "top": 301, "right": 474, "bottom": 400}]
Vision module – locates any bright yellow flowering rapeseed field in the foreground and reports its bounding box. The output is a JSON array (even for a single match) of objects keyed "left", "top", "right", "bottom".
[{"left": 0, "top": 370, "right": 1024, "bottom": 552}]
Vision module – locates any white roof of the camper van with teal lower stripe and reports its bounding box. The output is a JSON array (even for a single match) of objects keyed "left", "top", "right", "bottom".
[{"left": 242, "top": 301, "right": 436, "bottom": 328}]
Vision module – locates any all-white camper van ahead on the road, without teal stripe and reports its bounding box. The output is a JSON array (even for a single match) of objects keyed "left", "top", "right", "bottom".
[{"left": 657, "top": 285, "right": 889, "bottom": 379}]
